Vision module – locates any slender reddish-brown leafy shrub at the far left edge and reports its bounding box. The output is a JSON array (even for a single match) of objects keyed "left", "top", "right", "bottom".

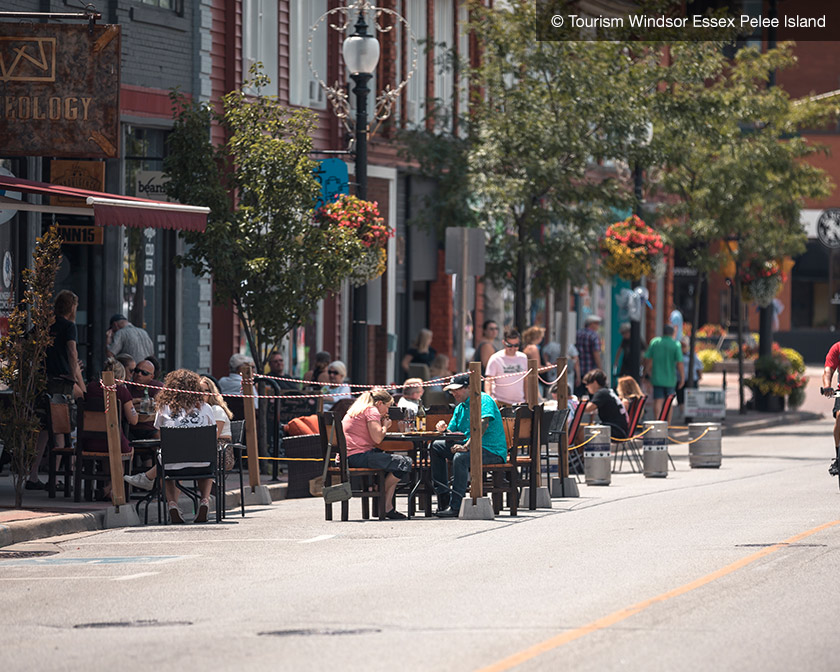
[{"left": 0, "top": 227, "right": 61, "bottom": 508}]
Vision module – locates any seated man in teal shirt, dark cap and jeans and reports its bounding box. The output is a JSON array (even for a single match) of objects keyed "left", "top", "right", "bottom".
[{"left": 431, "top": 374, "right": 507, "bottom": 518}]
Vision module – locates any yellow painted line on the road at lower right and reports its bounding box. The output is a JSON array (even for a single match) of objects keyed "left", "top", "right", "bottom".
[{"left": 476, "top": 520, "right": 840, "bottom": 672}]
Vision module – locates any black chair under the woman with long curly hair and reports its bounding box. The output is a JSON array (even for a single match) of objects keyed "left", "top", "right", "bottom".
[{"left": 158, "top": 424, "right": 224, "bottom": 523}]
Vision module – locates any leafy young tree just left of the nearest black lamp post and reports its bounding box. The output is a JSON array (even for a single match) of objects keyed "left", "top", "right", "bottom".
[{"left": 164, "top": 67, "right": 368, "bottom": 371}]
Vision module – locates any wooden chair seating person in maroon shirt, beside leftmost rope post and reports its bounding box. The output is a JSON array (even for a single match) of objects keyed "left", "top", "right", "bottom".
[{"left": 73, "top": 398, "right": 134, "bottom": 502}]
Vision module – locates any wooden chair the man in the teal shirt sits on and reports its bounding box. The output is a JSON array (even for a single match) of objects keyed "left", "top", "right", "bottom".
[{"left": 482, "top": 405, "right": 542, "bottom": 516}]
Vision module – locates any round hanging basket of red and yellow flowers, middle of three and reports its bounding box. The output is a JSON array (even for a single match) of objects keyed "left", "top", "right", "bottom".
[{"left": 598, "top": 215, "right": 665, "bottom": 281}]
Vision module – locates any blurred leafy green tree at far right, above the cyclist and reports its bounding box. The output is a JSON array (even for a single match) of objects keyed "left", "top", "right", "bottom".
[{"left": 653, "top": 42, "right": 837, "bottom": 407}]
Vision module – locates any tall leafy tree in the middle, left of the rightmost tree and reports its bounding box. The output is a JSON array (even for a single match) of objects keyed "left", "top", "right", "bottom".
[{"left": 462, "top": 0, "right": 659, "bottom": 328}]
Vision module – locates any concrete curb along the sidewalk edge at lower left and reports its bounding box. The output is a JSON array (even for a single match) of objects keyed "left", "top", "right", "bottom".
[{"left": 0, "top": 483, "right": 288, "bottom": 548}]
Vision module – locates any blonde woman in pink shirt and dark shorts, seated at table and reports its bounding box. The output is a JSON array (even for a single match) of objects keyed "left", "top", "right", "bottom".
[{"left": 341, "top": 389, "right": 411, "bottom": 520}]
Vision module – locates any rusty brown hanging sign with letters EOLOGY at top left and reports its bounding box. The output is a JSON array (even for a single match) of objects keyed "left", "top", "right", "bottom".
[{"left": 0, "top": 22, "right": 120, "bottom": 158}]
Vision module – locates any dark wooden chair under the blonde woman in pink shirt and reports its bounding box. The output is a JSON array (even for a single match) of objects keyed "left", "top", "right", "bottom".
[{"left": 318, "top": 411, "right": 386, "bottom": 521}]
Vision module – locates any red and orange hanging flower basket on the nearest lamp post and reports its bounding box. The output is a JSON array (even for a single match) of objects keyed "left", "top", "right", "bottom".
[{"left": 315, "top": 194, "right": 394, "bottom": 287}]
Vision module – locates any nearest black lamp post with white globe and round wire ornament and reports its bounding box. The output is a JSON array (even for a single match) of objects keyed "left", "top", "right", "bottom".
[{"left": 307, "top": 0, "right": 417, "bottom": 384}]
